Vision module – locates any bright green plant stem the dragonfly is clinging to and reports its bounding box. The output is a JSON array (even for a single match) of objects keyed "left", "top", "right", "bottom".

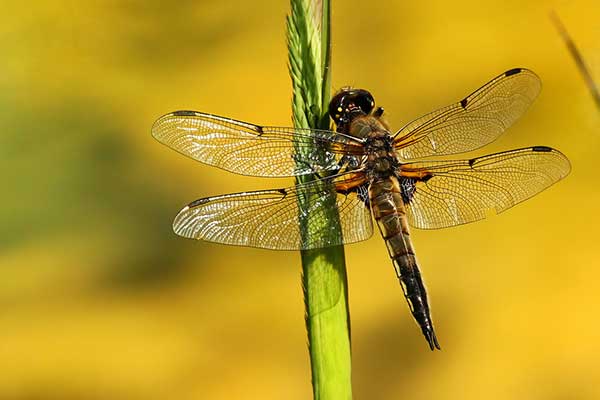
[{"left": 287, "top": 0, "right": 352, "bottom": 400}]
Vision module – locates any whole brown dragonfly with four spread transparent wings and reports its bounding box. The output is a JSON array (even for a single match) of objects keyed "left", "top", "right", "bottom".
[{"left": 152, "top": 68, "right": 571, "bottom": 350}]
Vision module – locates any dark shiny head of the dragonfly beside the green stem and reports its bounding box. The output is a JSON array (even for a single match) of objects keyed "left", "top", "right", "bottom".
[{"left": 329, "top": 88, "right": 375, "bottom": 131}]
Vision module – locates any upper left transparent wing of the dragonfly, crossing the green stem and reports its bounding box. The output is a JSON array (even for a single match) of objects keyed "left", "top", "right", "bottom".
[{"left": 152, "top": 111, "right": 363, "bottom": 177}]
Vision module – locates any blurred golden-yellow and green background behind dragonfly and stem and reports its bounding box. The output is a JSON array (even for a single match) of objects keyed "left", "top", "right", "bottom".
[{"left": 0, "top": 0, "right": 600, "bottom": 400}]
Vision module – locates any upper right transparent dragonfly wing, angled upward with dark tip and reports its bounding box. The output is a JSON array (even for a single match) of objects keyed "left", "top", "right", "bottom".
[{"left": 394, "top": 68, "right": 541, "bottom": 159}]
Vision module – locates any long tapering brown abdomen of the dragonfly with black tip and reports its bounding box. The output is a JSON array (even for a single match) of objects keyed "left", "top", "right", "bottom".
[{"left": 369, "top": 176, "right": 440, "bottom": 350}]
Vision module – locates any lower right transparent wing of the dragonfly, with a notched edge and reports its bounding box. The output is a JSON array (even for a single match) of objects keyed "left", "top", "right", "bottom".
[{"left": 401, "top": 146, "right": 571, "bottom": 229}]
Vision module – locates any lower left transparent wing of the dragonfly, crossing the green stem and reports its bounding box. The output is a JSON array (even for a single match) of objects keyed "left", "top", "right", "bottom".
[{"left": 173, "top": 172, "right": 373, "bottom": 250}]
